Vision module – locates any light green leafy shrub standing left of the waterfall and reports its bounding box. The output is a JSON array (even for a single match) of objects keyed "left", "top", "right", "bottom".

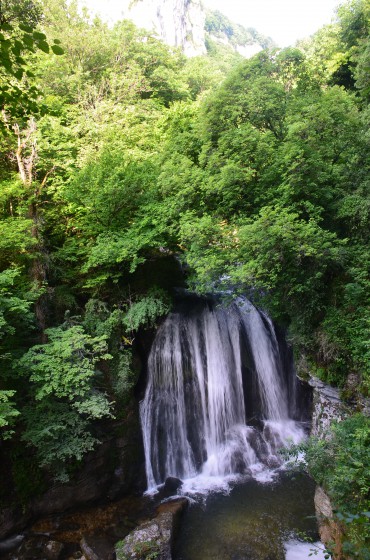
[{"left": 17, "top": 325, "right": 112, "bottom": 478}]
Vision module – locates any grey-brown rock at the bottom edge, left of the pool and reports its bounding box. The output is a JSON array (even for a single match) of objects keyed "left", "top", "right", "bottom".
[{"left": 116, "top": 498, "right": 188, "bottom": 560}]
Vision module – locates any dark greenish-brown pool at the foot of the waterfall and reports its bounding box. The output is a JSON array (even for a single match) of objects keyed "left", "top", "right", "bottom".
[{"left": 174, "top": 473, "right": 321, "bottom": 560}]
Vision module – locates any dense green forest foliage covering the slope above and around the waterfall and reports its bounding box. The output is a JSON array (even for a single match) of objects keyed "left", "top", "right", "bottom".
[{"left": 0, "top": 0, "right": 370, "bottom": 548}]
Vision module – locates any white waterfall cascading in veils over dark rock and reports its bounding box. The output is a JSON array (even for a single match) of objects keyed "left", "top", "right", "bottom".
[{"left": 140, "top": 298, "right": 303, "bottom": 488}]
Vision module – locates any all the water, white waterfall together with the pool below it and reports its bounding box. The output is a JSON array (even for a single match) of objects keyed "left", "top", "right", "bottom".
[{"left": 140, "top": 299, "right": 323, "bottom": 560}]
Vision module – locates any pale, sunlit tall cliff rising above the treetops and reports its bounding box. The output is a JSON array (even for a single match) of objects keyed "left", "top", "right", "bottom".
[{"left": 118, "top": 0, "right": 271, "bottom": 57}]
